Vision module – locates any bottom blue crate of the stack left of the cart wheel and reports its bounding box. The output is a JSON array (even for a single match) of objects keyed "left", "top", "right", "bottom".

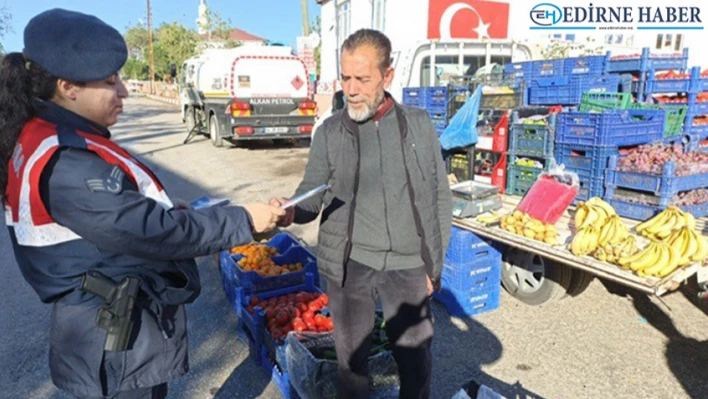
[{"left": 433, "top": 285, "right": 501, "bottom": 318}]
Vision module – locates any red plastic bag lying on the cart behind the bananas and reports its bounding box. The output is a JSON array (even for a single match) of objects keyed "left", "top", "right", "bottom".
[{"left": 516, "top": 160, "right": 580, "bottom": 224}]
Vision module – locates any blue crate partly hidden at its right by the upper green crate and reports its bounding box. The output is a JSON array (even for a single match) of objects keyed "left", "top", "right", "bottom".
[{"left": 528, "top": 75, "right": 619, "bottom": 105}]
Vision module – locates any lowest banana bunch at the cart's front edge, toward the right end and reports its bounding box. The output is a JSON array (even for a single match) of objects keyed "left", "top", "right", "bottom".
[{"left": 617, "top": 240, "right": 681, "bottom": 277}]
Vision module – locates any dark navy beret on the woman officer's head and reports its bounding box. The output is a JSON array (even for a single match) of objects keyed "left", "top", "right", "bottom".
[{"left": 24, "top": 8, "right": 128, "bottom": 82}]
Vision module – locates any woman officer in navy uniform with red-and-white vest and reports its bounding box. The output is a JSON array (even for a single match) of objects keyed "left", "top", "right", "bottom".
[{"left": 0, "top": 9, "right": 284, "bottom": 398}]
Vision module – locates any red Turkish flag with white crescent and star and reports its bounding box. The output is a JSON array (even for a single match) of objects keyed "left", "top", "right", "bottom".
[{"left": 428, "top": 0, "right": 509, "bottom": 39}]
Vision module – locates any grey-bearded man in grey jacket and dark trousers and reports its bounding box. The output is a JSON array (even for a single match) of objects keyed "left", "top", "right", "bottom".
[{"left": 271, "top": 29, "right": 452, "bottom": 398}]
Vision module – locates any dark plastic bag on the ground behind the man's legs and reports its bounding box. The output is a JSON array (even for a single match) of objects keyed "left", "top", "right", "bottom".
[{"left": 285, "top": 332, "right": 399, "bottom": 399}]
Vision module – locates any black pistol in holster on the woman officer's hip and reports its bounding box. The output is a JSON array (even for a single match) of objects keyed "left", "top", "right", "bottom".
[{"left": 81, "top": 270, "right": 140, "bottom": 352}]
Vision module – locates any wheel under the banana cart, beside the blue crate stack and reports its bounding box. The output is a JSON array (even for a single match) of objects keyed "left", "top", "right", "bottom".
[{"left": 502, "top": 248, "right": 572, "bottom": 305}]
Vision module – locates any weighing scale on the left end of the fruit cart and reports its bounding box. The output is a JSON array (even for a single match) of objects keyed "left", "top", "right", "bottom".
[{"left": 450, "top": 180, "right": 502, "bottom": 218}]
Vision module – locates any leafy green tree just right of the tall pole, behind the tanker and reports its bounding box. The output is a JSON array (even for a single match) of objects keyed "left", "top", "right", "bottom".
[{"left": 153, "top": 22, "right": 197, "bottom": 79}]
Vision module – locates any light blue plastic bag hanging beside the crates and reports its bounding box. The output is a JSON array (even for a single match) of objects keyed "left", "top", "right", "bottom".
[{"left": 440, "top": 85, "right": 482, "bottom": 150}]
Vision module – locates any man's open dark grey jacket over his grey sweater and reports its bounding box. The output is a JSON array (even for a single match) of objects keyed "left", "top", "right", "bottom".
[{"left": 295, "top": 96, "right": 452, "bottom": 285}]
